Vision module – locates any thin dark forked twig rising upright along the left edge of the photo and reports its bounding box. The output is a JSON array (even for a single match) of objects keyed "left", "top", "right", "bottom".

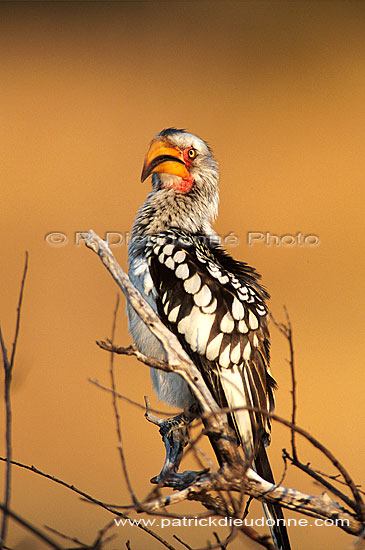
[{"left": 0, "top": 252, "right": 28, "bottom": 549}]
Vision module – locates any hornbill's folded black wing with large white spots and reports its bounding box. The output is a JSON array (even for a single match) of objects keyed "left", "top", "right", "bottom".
[{"left": 148, "top": 230, "right": 275, "bottom": 456}]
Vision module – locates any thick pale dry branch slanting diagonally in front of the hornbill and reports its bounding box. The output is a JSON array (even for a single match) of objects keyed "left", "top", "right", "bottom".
[{"left": 83, "top": 231, "right": 364, "bottom": 535}]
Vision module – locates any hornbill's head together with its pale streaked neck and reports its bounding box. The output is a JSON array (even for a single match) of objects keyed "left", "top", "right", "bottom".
[{"left": 134, "top": 128, "right": 219, "bottom": 234}]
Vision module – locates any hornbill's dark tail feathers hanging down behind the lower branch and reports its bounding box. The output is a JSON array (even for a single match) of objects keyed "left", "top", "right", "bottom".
[{"left": 255, "top": 446, "right": 291, "bottom": 550}]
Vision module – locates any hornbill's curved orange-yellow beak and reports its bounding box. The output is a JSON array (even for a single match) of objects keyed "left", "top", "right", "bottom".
[{"left": 141, "top": 137, "right": 189, "bottom": 182}]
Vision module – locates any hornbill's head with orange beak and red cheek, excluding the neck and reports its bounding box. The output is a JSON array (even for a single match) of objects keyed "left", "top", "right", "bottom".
[{"left": 141, "top": 128, "right": 219, "bottom": 194}]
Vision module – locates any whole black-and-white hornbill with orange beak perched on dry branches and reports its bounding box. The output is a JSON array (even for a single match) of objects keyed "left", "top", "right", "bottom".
[{"left": 128, "top": 128, "right": 290, "bottom": 550}]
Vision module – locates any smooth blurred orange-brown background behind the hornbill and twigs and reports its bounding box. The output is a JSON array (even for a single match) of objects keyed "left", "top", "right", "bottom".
[{"left": 0, "top": 1, "right": 365, "bottom": 550}]
